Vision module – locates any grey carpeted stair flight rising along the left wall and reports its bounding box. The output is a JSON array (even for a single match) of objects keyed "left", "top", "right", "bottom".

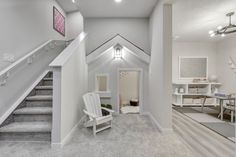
[{"left": 0, "top": 72, "right": 53, "bottom": 141}]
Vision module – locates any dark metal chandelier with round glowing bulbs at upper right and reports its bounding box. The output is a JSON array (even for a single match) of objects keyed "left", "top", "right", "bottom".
[{"left": 209, "top": 12, "right": 236, "bottom": 37}]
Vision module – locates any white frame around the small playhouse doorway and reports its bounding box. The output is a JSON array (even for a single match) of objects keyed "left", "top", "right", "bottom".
[{"left": 117, "top": 68, "right": 143, "bottom": 114}]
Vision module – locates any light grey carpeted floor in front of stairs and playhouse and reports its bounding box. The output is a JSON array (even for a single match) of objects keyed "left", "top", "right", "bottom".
[{"left": 0, "top": 115, "right": 197, "bottom": 157}]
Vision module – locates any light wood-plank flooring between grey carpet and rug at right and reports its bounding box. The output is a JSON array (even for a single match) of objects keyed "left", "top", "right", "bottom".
[{"left": 173, "top": 110, "right": 235, "bottom": 157}]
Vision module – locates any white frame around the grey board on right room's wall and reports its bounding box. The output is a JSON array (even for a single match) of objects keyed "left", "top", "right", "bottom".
[{"left": 179, "top": 56, "right": 209, "bottom": 80}]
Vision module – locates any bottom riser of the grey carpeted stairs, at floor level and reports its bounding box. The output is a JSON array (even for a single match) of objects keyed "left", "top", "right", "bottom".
[{"left": 0, "top": 132, "right": 51, "bottom": 141}]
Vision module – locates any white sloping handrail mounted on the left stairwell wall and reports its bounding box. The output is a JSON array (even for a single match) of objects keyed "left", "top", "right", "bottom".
[{"left": 0, "top": 40, "right": 52, "bottom": 76}]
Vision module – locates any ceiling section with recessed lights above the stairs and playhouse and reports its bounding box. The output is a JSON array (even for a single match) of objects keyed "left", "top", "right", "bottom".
[{"left": 57, "top": 0, "right": 157, "bottom": 17}]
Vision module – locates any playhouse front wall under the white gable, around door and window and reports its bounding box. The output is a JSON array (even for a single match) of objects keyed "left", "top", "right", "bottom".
[{"left": 88, "top": 50, "right": 148, "bottom": 112}]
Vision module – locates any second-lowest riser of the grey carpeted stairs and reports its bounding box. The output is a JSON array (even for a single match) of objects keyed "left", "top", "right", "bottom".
[{"left": 14, "top": 115, "right": 52, "bottom": 122}]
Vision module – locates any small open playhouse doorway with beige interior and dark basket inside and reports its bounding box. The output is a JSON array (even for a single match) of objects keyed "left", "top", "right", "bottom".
[{"left": 117, "top": 69, "right": 142, "bottom": 114}]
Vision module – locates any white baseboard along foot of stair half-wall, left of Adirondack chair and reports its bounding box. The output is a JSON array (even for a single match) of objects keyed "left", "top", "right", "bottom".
[{"left": 51, "top": 116, "right": 86, "bottom": 149}]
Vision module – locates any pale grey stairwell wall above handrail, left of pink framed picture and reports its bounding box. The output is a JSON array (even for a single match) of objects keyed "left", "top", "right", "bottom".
[{"left": 0, "top": 0, "right": 65, "bottom": 70}]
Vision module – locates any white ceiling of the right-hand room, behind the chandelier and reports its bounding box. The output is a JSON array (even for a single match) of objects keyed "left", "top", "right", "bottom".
[{"left": 173, "top": 0, "right": 236, "bottom": 42}]
